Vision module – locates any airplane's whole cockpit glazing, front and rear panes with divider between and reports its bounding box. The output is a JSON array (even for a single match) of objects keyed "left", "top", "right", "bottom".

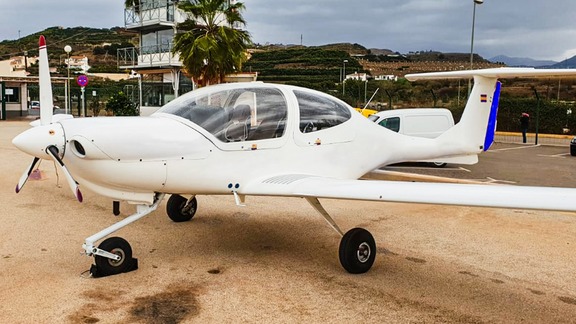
[{"left": 158, "top": 83, "right": 351, "bottom": 142}]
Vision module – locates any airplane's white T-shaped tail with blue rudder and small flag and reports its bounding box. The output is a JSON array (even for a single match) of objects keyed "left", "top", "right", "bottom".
[{"left": 406, "top": 68, "right": 576, "bottom": 158}]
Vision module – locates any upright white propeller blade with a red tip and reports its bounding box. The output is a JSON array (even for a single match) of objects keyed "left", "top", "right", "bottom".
[{"left": 38, "top": 36, "right": 54, "bottom": 125}]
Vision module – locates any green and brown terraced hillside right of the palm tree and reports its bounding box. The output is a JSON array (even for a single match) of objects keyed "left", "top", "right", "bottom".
[{"left": 249, "top": 43, "right": 501, "bottom": 89}]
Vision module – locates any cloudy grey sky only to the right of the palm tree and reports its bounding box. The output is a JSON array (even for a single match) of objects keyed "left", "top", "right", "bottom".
[{"left": 244, "top": 0, "right": 576, "bottom": 59}]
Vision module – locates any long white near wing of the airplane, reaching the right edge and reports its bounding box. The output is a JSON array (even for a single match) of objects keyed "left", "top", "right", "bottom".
[{"left": 238, "top": 174, "right": 576, "bottom": 211}]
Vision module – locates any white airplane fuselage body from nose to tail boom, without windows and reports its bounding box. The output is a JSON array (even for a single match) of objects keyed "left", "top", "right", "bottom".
[{"left": 14, "top": 83, "right": 476, "bottom": 203}]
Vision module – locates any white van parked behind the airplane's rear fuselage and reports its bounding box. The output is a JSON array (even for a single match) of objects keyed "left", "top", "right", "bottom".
[{"left": 368, "top": 108, "right": 454, "bottom": 167}]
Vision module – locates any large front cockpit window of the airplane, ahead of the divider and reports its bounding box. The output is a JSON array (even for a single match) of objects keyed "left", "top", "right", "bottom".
[{"left": 162, "top": 88, "right": 288, "bottom": 142}]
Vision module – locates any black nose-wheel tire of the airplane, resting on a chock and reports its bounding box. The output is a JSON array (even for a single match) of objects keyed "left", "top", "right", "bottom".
[{"left": 94, "top": 237, "right": 133, "bottom": 276}]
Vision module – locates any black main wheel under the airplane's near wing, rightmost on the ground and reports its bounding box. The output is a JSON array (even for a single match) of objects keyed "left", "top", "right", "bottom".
[{"left": 339, "top": 228, "right": 376, "bottom": 274}]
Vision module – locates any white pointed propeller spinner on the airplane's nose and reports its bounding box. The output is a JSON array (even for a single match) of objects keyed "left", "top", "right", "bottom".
[{"left": 12, "top": 124, "right": 66, "bottom": 159}]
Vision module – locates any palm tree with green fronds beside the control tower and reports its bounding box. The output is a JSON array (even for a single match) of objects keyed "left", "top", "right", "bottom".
[{"left": 172, "top": 0, "right": 251, "bottom": 86}]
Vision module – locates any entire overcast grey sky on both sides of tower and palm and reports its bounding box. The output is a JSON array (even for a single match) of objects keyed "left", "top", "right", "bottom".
[{"left": 0, "top": 0, "right": 576, "bottom": 61}]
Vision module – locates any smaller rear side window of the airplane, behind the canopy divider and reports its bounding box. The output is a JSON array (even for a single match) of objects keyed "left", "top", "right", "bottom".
[{"left": 294, "top": 90, "right": 352, "bottom": 133}]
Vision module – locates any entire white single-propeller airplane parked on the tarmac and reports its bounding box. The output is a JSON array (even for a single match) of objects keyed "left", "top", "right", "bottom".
[{"left": 13, "top": 37, "right": 576, "bottom": 276}]
